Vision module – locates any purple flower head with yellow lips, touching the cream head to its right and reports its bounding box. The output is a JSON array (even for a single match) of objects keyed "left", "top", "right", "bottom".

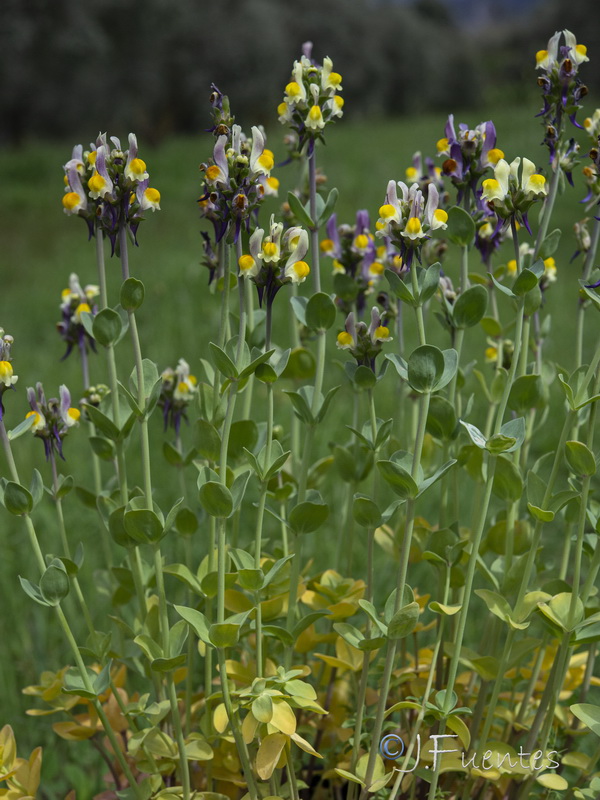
[{"left": 437, "top": 114, "right": 504, "bottom": 203}]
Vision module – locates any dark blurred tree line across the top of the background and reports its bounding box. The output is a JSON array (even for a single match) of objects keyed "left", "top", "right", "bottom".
[{"left": 0, "top": 0, "right": 600, "bottom": 144}]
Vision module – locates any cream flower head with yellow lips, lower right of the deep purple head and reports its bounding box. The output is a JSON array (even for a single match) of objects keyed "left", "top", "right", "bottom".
[{"left": 482, "top": 158, "right": 548, "bottom": 233}]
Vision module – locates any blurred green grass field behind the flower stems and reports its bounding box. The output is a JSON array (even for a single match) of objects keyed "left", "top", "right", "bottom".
[{"left": 0, "top": 102, "right": 598, "bottom": 800}]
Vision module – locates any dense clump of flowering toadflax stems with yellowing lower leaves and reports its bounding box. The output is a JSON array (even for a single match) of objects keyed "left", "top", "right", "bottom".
[{"left": 0, "top": 31, "right": 600, "bottom": 800}]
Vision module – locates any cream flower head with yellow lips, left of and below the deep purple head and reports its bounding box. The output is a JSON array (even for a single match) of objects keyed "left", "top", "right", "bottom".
[{"left": 375, "top": 181, "right": 448, "bottom": 269}]
